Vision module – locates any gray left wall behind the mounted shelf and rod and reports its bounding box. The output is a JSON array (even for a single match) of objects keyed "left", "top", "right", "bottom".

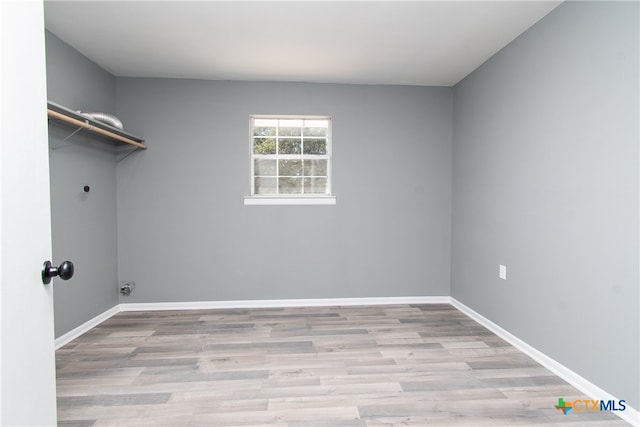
[{"left": 46, "top": 32, "right": 118, "bottom": 336}]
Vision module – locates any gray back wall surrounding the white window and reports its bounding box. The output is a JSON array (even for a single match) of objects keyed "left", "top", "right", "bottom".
[{"left": 116, "top": 78, "right": 452, "bottom": 302}]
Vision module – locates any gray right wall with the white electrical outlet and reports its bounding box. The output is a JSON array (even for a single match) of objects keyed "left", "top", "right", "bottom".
[{"left": 451, "top": 2, "right": 640, "bottom": 408}]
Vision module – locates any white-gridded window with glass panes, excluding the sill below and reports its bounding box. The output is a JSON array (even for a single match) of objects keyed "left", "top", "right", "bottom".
[{"left": 246, "top": 116, "right": 331, "bottom": 205}]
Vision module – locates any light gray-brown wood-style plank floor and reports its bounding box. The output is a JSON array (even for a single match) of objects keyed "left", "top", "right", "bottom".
[{"left": 57, "top": 305, "right": 628, "bottom": 427}]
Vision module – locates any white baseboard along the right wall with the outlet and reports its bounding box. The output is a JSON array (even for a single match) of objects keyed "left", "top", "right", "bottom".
[{"left": 450, "top": 297, "right": 640, "bottom": 426}]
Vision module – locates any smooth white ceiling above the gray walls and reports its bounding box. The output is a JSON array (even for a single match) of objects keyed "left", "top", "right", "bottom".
[{"left": 45, "top": 0, "right": 561, "bottom": 86}]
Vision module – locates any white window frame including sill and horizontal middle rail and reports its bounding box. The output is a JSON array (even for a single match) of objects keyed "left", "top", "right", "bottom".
[{"left": 244, "top": 114, "right": 336, "bottom": 205}]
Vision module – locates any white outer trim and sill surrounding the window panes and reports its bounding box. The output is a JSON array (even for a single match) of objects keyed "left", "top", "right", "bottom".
[{"left": 244, "top": 114, "right": 336, "bottom": 206}]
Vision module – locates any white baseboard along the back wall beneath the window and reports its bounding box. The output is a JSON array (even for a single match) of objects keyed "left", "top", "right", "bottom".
[{"left": 120, "top": 296, "right": 451, "bottom": 311}]
